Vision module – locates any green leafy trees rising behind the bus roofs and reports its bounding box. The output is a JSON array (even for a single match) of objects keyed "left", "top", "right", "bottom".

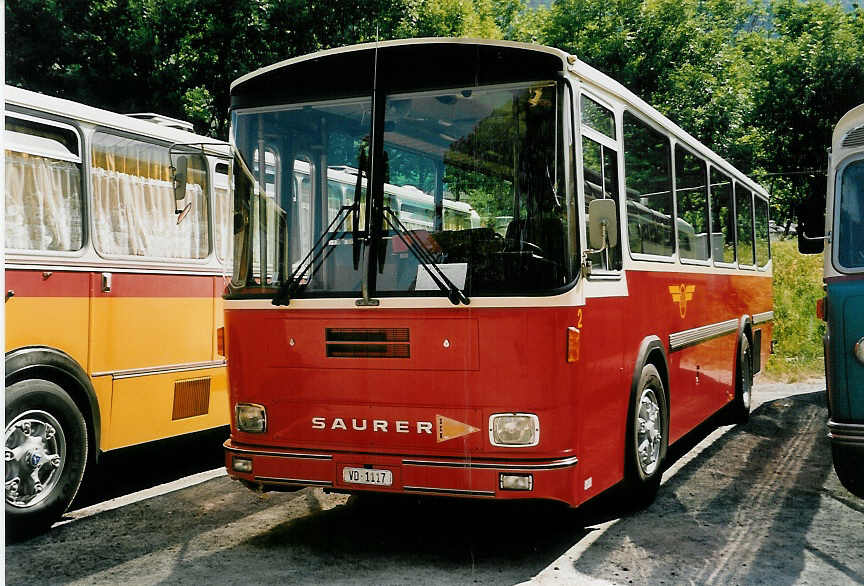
[{"left": 5, "top": 0, "right": 864, "bottom": 235}]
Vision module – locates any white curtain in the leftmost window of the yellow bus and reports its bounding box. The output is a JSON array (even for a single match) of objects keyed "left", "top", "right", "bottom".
[{"left": 5, "top": 150, "right": 82, "bottom": 250}]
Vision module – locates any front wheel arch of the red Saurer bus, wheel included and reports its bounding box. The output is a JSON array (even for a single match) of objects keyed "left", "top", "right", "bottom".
[{"left": 623, "top": 336, "right": 669, "bottom": 509}]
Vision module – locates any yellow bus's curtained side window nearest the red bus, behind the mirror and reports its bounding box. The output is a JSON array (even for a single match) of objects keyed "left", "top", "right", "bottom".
[{"left": 92, "top": 132, "right": 210, "bottom": 259}]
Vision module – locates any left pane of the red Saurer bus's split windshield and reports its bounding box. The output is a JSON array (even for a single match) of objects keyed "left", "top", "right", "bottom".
[{"left": 232, "top": 99, "right": 371, "bottom": 294}]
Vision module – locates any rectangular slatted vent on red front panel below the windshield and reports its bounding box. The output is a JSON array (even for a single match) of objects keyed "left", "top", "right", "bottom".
[{"left": 324, "top": 328, "right": 411, "bottom": 358}]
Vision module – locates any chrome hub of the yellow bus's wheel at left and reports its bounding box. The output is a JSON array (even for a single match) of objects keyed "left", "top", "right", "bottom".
[{"left": 3, "top": 411, "right": 66, "bottom": 509}]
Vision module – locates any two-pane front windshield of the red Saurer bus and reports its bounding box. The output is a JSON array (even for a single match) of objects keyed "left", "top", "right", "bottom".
[{"left": 232, "top": 82, "right": 578, "bottom": 297}]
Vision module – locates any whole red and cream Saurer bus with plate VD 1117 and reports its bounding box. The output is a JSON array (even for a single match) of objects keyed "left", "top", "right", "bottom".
[{"left": 225, "top": 39, "right": 773, "bottom": 506}]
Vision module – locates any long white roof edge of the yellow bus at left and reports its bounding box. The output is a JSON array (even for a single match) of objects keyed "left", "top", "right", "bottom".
[{"left": 3, "top": 85, "right": 230, "bottom": 156}]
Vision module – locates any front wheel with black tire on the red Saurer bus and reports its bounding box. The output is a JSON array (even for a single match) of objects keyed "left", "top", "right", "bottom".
[{"left": 624, "top": 364, "right": 669, "bottom": 509}]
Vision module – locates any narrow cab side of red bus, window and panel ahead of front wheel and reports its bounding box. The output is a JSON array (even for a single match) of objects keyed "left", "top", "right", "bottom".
[{"left": 574, "top": 93, "right": 632, "bottom": 496}]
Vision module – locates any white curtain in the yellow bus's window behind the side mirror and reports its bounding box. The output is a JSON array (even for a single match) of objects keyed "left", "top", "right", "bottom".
[{"left": 93, "top": 167, "right": 208, "bottom": 258}]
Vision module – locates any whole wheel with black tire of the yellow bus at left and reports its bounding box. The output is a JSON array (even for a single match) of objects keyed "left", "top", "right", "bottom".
[{"left": 4, "top": 379, "right": 87, "bottom": 540}]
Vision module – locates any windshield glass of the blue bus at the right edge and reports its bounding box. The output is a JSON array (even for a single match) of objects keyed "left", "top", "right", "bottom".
[{"left": 834, "top": 160, "right": 864, "bottom": 269}]
